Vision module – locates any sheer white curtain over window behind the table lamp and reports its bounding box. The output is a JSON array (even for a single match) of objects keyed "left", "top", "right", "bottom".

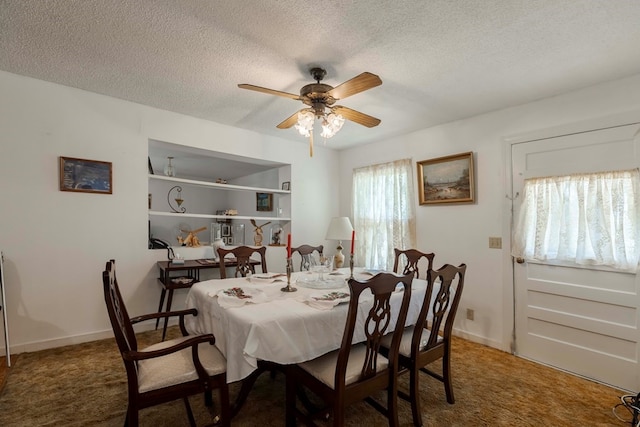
[{"left": 352, "top": 159, "right": 416, "bottom": 270}]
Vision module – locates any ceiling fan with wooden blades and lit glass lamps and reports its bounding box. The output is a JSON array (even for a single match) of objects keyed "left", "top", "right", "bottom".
[{"left": 238, "top": 67, "right": 382, "bottom": 156}]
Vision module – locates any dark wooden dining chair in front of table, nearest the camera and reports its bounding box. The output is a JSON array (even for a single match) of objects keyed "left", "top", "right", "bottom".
[{"left": 285, "top": 273, "right": 413, "bottom": 426}]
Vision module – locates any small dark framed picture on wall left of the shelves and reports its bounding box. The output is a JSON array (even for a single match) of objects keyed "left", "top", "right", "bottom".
[{"left": 60, "top": 156, "right": 112, "bottom": 194}]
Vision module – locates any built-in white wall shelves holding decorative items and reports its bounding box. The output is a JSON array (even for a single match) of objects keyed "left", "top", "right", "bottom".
[{"left": 147, "top": 140, "right": 292, "bottom": 245}]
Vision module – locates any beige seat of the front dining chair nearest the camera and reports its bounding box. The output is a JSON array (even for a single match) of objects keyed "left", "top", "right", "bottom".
[{"left": 298, "top": 344, "right": 389, "bottom": 388}]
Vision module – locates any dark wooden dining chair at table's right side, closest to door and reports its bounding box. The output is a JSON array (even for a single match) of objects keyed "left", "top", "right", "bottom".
[{"left": 382, "top": 264, "right": 467, "bottom": 426}]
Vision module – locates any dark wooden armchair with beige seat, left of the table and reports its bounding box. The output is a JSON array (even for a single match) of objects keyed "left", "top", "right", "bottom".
[{"left": 102, "top": 260, "right": 230, "bottom": 427}]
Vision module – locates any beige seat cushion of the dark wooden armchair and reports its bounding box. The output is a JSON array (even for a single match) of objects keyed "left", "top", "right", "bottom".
[{"left": 138, "top": 336, "right": 227, "bottom": 393}]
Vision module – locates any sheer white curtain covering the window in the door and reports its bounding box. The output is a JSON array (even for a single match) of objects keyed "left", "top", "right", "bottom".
[{"left": 513, "top": 169, "right": 640, "bottom": 270}]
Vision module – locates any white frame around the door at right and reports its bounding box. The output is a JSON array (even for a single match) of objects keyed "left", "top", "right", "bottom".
[{"left": 502, "top": 109, "right": 640, "bottom": 354}]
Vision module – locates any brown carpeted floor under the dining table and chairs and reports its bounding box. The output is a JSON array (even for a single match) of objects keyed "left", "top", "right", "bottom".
[{"left": 0, "top": 332, "right": 630, "bottom": 427}]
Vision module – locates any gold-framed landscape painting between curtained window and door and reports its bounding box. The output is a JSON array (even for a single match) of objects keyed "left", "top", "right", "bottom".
[{"left": 417, "top": 151, "right": 475, "bottom": 205}]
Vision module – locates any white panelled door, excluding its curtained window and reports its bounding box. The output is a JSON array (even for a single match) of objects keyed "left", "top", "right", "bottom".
[{"left": 511, "top": 123, "right": 640, "bottom": 391}]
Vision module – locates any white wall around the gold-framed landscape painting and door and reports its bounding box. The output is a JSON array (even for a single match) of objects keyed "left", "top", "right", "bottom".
[{"left": 340, "top": 75, "right": 640, "bottom": 350}]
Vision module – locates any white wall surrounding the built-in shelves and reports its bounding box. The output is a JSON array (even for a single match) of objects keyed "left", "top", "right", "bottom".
[{"left": 0, "top": 72, "right": 338, "bottom": 353}]
